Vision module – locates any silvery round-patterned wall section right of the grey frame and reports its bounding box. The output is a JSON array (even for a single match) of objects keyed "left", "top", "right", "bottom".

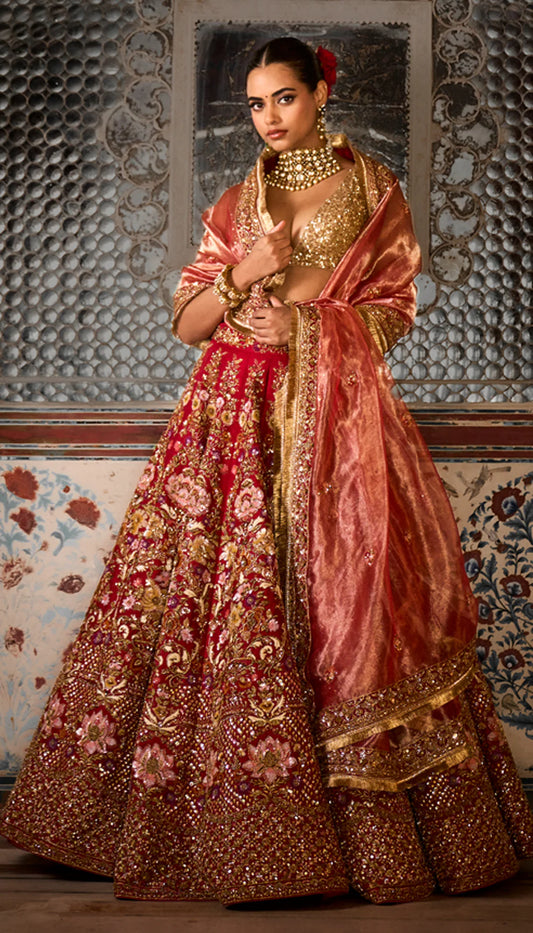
[{"left": 393, "top": 0, "right": 533, "bottom": 402}]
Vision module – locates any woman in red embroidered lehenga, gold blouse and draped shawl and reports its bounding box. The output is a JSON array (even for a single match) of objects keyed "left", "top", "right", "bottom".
[{"left": 2, "top": 39, "right": 533, "bottom": 904}]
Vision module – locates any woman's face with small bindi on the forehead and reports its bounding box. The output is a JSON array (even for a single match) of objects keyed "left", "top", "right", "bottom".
[{"left": 246, "top": 63, "right": 328, "bottom": 152}]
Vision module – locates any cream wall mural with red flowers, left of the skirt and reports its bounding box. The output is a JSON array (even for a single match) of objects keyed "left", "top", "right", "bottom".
[{"left": 0, "top": 461, "right": 141, "bottom": 779}]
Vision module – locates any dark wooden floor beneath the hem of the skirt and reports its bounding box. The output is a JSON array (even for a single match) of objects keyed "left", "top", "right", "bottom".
[{"left": 0, "top": 840, "right": 533, "bottom": 933}]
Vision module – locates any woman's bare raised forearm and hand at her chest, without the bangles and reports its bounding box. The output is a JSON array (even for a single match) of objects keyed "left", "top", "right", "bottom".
[{"left": 177, "top": 220, "right": 292, "bottom": 344}]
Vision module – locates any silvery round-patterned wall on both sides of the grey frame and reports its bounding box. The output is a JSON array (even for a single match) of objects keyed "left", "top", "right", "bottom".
[{"left": 0, "top": 0, "right": 533, "bottom": 404}]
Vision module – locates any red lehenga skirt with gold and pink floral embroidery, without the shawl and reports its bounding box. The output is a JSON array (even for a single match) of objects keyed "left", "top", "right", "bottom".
[{"left": 0, "top": 325, "right": 533, "bottom": 904}]
